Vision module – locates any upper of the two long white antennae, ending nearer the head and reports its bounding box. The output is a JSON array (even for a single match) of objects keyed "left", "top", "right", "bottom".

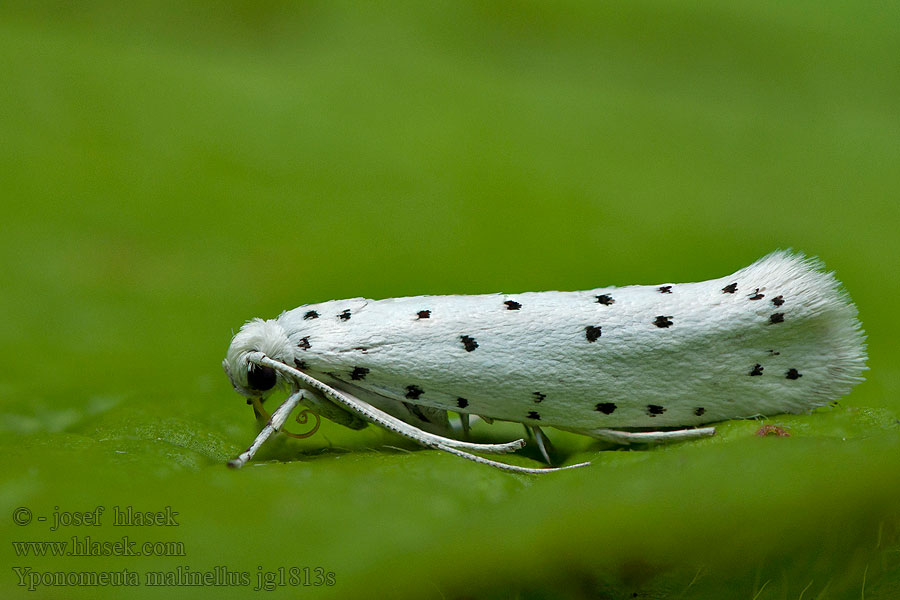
[{"left": 247, "top": 352, "right": 525, "bottom": 454}]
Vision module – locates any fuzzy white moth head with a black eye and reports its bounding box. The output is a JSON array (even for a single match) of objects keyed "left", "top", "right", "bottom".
[{"left": 222, "top": 319, "right": 293, "bottom": 398}]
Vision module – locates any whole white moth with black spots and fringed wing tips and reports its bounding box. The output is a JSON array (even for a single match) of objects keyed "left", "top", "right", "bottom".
[{"left": 223, "top": 251, "right": 866, "bottom": 473}]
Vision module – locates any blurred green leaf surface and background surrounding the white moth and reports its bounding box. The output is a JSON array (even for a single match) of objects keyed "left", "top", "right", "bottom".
[{"left": 0, "top": 0, "right": 900, "bottom": 600}]
